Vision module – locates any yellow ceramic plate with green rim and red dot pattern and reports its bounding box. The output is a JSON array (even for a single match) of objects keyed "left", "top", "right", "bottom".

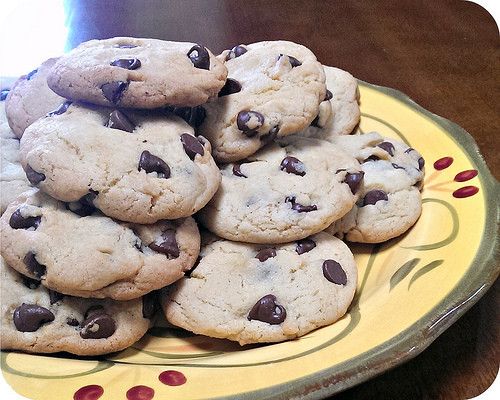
[{"left": 1, "top": 66, "right": 500, "bottom": 400}]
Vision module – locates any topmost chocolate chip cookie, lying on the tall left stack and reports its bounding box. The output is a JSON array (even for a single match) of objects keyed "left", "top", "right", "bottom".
[{"left": 47, "top": 37, "right": 227, "bottom": 108}]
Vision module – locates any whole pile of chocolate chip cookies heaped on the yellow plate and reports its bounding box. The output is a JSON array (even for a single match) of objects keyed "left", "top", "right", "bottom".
[{"left": 0, "top": 37, "right": 424, "bottom": 355}]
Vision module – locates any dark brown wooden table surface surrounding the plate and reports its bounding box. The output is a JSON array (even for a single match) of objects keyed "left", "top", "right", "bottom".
[{"left": 11, "top": 0, "right": 500, "bottom": 400}]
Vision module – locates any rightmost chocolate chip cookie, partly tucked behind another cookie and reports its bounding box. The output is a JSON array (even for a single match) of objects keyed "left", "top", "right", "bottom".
[{"left": 326, "top": 132, "right": 425, "bottom": 243}]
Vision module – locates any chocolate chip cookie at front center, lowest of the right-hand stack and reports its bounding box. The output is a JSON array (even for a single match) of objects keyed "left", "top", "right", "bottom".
[{"left": 160, "top": 232, "right": 357, "bottom": 345}]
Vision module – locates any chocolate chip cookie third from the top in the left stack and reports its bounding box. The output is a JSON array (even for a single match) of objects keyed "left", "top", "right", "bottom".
[{"left": 0, "top": 189, "right": 200, "bottom": 300}]
